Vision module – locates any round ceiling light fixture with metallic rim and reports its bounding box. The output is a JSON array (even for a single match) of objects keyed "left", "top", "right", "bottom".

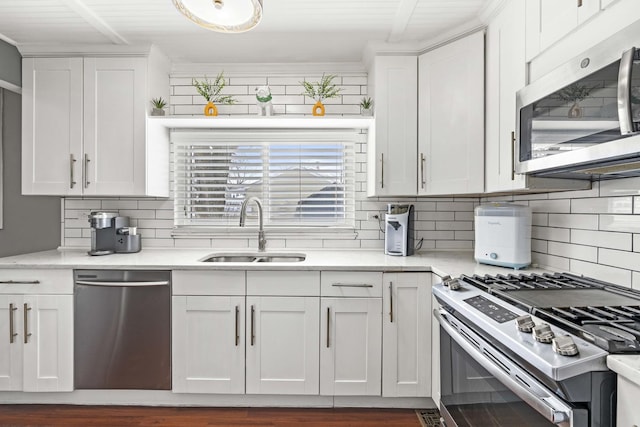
[{"left": 173, "top": 0, "right": 262, "bottom": 33}]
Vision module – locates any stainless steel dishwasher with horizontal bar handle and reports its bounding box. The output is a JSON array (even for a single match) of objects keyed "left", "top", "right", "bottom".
[{"left": 74, "top": 270, "right": 171, "bottom": 390}]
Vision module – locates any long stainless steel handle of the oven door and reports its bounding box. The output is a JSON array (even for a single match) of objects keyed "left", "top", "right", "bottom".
[{"left": 434, "top": 309, "right": 573, "bottom": 427}]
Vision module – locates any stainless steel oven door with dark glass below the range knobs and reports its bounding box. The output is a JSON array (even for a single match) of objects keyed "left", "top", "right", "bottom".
[{"left": 435, "top": 309, "right": 588, "bottom": 427}]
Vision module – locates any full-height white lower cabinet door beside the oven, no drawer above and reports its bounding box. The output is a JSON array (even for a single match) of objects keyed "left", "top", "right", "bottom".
[{"left": 382, "top": 273, "right": 431, "bottom": 397}]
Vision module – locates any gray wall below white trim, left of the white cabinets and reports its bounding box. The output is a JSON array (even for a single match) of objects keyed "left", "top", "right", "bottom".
[{"left": 0, "top": 82, "right": 61, "bottom": 256}]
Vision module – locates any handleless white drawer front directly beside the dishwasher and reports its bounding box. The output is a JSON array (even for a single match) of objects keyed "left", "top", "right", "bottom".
[{"left": 171, "top": 270, "right": 245, "bottom": 295}]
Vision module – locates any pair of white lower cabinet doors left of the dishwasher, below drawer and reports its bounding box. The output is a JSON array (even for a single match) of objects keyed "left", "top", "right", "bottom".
[{"left": 0, "top": 295, "right": 73, "bottom": 392}]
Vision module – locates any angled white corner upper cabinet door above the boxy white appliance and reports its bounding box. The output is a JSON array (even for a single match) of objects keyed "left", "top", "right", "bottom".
[{"left": 417, "top": 32, "right": 484, "bottom": 195}]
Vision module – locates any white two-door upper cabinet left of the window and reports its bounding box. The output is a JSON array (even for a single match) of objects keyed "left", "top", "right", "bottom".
[{"left": 22, "top": 50, "right": 169, "bottom": 197}]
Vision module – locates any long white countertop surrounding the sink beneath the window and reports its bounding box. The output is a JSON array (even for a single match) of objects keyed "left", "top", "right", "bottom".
[{"left": 0, "top": 248, "right": 542, "bottom": 277}]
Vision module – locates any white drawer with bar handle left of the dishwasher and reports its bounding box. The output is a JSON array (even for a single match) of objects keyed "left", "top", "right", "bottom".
[{"left": 0, "top": 268, "right": 73, "bottom": 294}]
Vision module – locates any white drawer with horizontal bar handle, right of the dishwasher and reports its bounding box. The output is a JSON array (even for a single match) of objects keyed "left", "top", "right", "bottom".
[{"left": 320, "top": 271, "right": 382, "bottom": 297}]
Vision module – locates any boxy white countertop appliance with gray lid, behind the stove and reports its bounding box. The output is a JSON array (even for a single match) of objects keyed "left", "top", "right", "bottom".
[{"left": 475, "top": 203, "right": 531, "bottom": 269}]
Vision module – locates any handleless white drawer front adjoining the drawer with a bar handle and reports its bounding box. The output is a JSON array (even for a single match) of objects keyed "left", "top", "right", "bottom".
[{"left": 247, "top": 271, "right": 320, "bottom": 297}]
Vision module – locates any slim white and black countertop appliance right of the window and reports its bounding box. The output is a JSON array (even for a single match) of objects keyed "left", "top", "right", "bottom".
[{"left": 384, "top": 203, "right": 414, "bottom": 256}]
